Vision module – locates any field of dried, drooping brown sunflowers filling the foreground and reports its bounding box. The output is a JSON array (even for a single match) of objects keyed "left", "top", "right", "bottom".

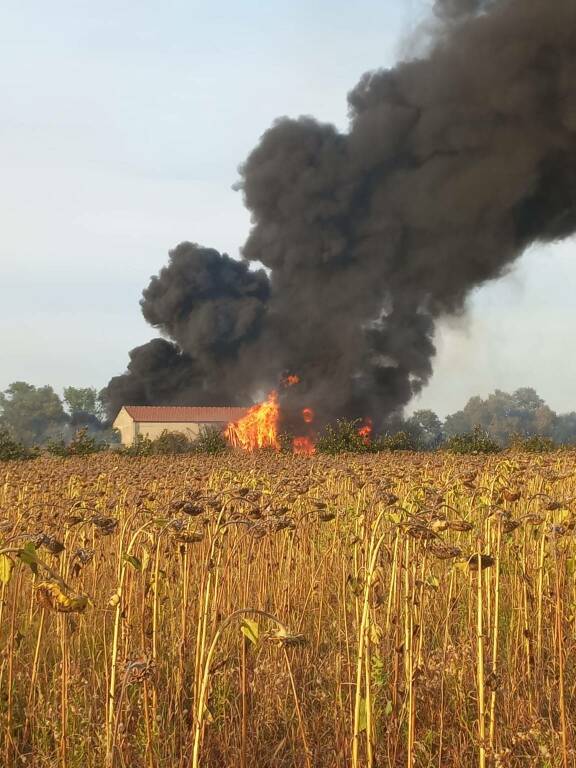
[{"left": 0, "top": 453, "right": 576, "bottom": 768}]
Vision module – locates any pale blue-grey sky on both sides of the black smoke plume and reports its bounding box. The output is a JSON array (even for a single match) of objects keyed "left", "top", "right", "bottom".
[{"left": 0, "top": 0, "right": 576, "bottom": 416}]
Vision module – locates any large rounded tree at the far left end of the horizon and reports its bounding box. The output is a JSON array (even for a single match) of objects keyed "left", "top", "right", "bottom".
[{"left": 0, "top": 381, "right": 68, "bottom": 445}]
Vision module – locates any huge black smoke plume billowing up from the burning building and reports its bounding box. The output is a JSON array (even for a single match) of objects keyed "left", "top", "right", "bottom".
[{"left": 110, "top": 0, "right": 576, "bottom": 424}]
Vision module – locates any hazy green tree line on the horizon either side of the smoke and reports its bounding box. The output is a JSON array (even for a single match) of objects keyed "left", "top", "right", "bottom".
[{"left": 0, "top": 381, "right": 576, "bottom": 449}]
